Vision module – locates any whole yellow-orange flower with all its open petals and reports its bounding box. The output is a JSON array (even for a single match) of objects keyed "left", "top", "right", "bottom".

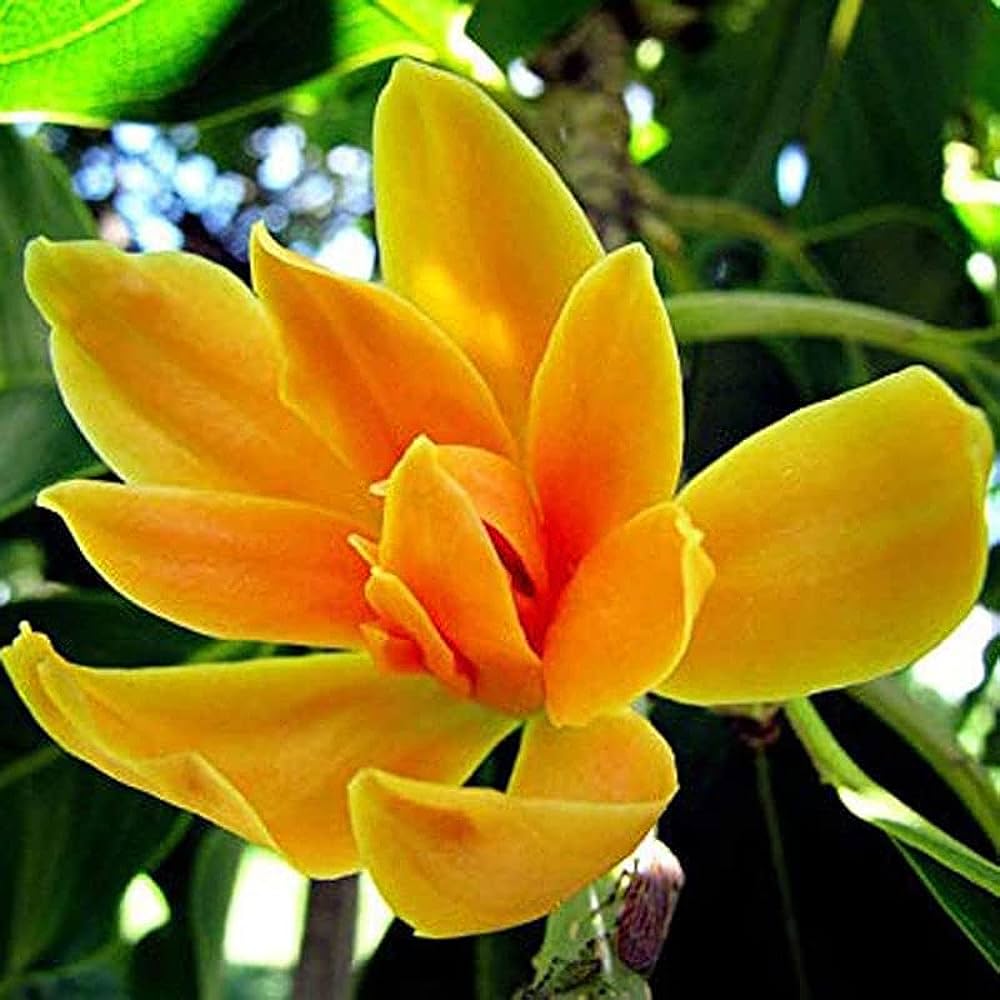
[{"left": 4, "top": 62, "right": 992, "bottom": 935}]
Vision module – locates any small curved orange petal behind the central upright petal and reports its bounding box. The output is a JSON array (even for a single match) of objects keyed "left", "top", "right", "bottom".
[{"left": 438, "top": 445, "right": 548, "bottom": 595}]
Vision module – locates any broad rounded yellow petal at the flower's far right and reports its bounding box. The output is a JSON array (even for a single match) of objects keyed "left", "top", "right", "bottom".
[{"left": 661, "top": 368, "right": 993, "bottom": 703}]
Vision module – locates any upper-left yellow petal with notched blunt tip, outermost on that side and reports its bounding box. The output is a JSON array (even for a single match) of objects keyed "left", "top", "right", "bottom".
[{"left": 25, "top": 240, "right": 374, "bottom": 524}]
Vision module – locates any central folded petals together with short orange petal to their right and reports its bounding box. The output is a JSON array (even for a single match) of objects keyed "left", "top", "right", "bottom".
[{"left": 352, "top": 437, "right": 712, "bottom": 725}]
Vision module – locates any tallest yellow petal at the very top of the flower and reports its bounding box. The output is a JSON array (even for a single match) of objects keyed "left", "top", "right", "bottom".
[{"left": 374, "top": 60, "right": 601, "bottom": 429}]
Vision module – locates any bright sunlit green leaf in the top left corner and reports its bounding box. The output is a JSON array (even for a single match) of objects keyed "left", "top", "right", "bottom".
[{"left": 0, "top": 0, "right": 457, "bottom": 124}]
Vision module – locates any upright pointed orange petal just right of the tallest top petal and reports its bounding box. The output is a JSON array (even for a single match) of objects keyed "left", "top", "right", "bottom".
[{"left": 527, "top": 245, "right": 683, "bottom": 575}]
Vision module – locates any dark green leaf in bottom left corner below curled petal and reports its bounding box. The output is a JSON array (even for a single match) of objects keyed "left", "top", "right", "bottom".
[{"left": 0, "top": 748, "right": 188, "bottom": 994}]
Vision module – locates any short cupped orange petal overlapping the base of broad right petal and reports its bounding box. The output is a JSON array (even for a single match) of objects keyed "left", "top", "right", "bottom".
[{"left": 542, "top": 502, "right": 713, "bottom": 725}]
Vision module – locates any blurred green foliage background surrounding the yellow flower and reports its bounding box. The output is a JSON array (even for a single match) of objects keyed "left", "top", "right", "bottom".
[{"left": 0, "top": 0, "right": 1000, "bottom": 1000}]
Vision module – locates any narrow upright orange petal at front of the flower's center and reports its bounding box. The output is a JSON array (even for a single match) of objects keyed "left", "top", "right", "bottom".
[{"left": 379, "top": 438, "right": 541, "bottom": 714}]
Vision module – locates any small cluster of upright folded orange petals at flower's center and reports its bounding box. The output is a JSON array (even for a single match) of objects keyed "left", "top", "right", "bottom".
[{"left": 352, "top": 439, "right": 552, "bottom": 715}]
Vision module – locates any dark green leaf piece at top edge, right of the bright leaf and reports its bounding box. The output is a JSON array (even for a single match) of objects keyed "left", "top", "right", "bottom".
[{"left": 466, "top": 0, "right": 597, "bottom": 66}]
